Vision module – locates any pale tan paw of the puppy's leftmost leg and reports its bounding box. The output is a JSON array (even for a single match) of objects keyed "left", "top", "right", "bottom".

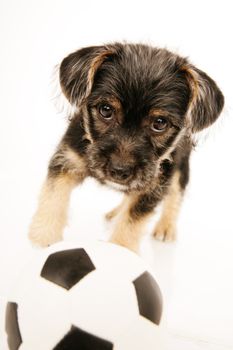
[{"left": 28, "top": 222, "right": 63, "bottom": 247}]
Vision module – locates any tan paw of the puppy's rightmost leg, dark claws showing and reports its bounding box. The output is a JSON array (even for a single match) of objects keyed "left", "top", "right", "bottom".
[{"left": 153, "top": 220, "right": 176, "bottom": 242}]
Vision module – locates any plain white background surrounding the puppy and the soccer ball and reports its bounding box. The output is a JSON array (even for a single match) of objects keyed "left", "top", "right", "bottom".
[{"left": 0, "top": 0, "right": 233, "bottom": 350}]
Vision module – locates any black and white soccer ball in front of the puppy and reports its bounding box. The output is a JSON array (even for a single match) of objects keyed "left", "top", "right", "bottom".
[{"left": 5, "top": 241, "right": 162, "bottom": 350}]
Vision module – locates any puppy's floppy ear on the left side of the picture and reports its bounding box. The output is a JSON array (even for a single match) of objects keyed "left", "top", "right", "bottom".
[{"left": 59, "top": 46, "right": 114, "bottom": 106}]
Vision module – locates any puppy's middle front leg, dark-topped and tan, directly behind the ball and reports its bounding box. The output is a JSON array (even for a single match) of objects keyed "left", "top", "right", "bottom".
[{"left": 110, "top": 192, "right": 160, "bottom": 253}]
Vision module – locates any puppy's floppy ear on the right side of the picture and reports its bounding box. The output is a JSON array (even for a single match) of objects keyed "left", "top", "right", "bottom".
[{"left": 182, "top": 65, "right": 224, "bottom": 132}]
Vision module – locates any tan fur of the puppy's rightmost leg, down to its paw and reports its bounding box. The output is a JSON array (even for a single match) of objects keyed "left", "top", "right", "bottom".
[{"left": 154, "top": 171, "right": 183, "bottom": 241}]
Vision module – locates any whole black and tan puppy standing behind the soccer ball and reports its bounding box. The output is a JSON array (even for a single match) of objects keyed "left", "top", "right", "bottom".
[{"left": 29, "top": 43, "right": 224, "bottom": 251}]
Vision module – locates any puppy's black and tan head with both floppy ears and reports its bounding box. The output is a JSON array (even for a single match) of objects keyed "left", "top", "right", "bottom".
[{"left": 60, "top": 43, "right": 224, "bottom": 190}]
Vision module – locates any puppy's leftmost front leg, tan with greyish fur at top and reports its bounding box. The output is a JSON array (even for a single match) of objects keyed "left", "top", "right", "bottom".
[{"left": 29, "top": 147, "right": 86, "bottom": 247}]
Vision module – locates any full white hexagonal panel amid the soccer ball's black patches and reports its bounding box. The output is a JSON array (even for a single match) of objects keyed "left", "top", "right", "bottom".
[{"left": 70, "top": 269, "right": 139, "bottom": 339}]
